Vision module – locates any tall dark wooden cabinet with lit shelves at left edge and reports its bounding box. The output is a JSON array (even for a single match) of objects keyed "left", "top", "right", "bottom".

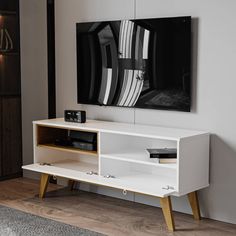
[{"left": 0, "top": 0, "right": 22, "bottom": 180}]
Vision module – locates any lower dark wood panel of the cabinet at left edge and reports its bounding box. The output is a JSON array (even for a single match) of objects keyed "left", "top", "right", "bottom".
[{"left": 1, "top": 97, "right": 22, "bottom": 176}]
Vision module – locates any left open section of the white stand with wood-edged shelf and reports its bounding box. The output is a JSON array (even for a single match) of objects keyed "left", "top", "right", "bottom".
[{"left": 33, "top": 124, "right": 99, "bottom": 174}]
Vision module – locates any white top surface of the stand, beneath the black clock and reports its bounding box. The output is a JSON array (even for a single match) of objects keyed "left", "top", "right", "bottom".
[{"left": 33, "top": 118, "right": 207, "bottom": 141}]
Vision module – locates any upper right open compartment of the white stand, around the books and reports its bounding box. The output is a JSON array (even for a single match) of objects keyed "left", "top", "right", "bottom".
[{"left": 101, "top": 133, "right": 178, "bottom": 169}]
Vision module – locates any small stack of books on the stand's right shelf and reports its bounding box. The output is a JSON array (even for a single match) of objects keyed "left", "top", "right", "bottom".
[{"left": 147, "top": 148, "right": 177, "bottom": 164}]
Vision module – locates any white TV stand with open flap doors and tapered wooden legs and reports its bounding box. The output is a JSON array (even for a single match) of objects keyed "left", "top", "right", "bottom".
[{"left": 23, "top": 118, "right": 209, "bottom": 231}]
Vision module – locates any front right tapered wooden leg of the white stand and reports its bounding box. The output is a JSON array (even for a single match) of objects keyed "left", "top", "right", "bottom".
[{"left": 160, "top": 197, "right": 175, "bottom": 231}]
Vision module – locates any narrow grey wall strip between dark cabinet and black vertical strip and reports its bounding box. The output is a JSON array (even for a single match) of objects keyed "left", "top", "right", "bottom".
[{"left": 20, "top": 0, "right": 47, "bottom": 176}]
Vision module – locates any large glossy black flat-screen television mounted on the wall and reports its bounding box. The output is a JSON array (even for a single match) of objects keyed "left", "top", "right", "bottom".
[{"left": 76, "top": 17, "right": 191, "bottom": 111}]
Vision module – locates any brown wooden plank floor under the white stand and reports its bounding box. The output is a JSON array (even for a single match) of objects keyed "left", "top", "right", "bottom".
[{"left": 0, "top": 178, "right": 236, "bottom": 236}]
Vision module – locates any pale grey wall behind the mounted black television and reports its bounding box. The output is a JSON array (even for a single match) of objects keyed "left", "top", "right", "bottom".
[{"left": 53, "top": 0, "right": 236, "bottom": 223}]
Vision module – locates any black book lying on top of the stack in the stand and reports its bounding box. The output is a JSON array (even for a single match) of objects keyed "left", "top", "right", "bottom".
[{"left": 147, "top": 148, "right": 177, "bottom": 159}]
